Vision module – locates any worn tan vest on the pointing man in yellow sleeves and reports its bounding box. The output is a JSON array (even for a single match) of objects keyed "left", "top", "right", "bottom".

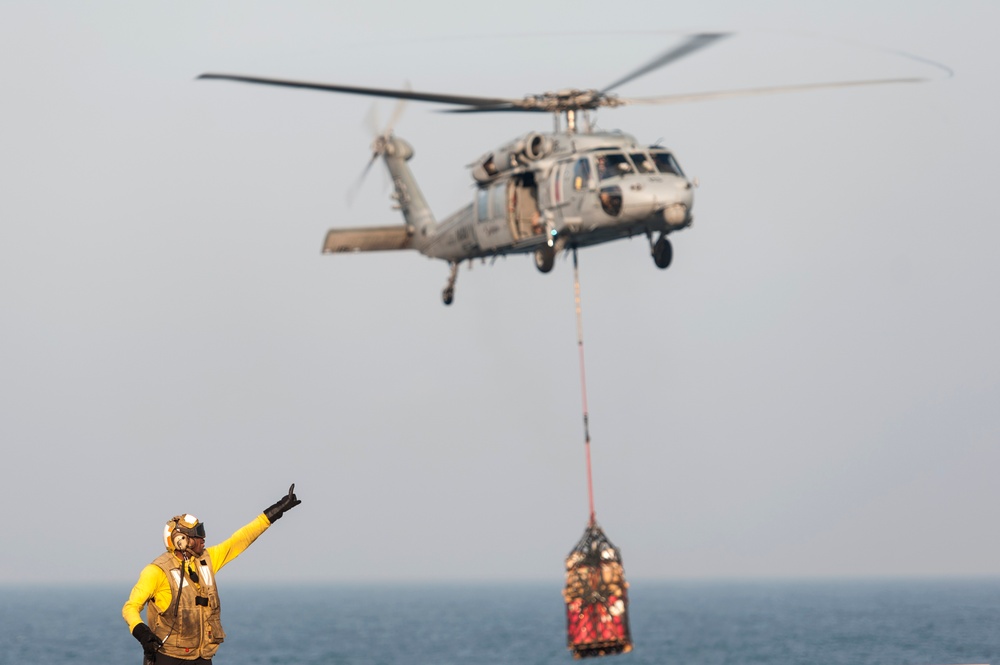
[{"left": 146, "top": 551, "right": 226, "bottom": 660}]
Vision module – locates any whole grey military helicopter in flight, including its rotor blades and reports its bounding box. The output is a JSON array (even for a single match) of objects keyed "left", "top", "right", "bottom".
[{"left": 198, "top": 33, "right": 926, "bottom": 305}]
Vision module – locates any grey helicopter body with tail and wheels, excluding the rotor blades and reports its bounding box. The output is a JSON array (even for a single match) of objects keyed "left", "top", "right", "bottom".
[{"left": 323, "top": 127, "right": 694, "bottom": 302}]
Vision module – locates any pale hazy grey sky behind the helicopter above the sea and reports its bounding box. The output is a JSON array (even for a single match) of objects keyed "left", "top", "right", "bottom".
[{"left": 0, "top": 0, "right": 1000, "bottom": 593}]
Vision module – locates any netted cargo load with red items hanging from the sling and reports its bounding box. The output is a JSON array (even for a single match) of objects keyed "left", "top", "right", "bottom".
[{"left": 563, "top": 521, "right": 632, "bottom": 658}]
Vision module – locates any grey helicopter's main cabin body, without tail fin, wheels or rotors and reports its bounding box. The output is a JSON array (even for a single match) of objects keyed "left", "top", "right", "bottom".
[{"left": 426, "top": 133, "right": 693, "bottom": 261}]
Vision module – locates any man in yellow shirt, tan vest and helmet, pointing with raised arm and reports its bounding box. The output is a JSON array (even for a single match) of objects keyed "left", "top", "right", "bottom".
[{"left": 122, "top": 483, "right": 302, "bottom": 665}]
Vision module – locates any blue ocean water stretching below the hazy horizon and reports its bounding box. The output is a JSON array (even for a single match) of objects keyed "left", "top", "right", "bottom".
[{"left": 0, "top": 579, "right": 1000, "bottom": 665}]
